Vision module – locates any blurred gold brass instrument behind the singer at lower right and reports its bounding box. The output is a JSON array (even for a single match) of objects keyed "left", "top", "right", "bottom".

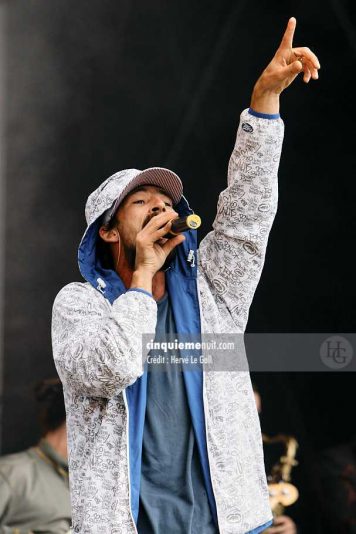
[{"left": 262, "top": 434, "right": 299, "bottom": 516}]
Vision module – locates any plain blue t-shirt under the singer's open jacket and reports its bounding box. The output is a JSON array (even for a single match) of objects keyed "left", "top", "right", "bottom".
[{"left": 137, "top": 294, "right": 219, "bottom": 534}]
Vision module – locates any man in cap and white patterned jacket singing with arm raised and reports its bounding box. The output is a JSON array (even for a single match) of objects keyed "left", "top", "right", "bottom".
[{"left": 52, "top": 18, "right": 320, "bottom": 534}]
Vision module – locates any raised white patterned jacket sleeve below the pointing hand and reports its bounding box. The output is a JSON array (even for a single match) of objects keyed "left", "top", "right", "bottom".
[{"left": 199, "top": 110, "right": 284, "bottom": 332}]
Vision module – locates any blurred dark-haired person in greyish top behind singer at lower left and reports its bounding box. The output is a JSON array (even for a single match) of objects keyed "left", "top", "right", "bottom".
[{"left": 0, "top": 378, "right": 71, "bottom": 534}]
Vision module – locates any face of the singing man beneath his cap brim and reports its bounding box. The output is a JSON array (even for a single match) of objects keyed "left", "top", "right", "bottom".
[{"left": 115, "top": 185, "right": 173, "bottom": 268}]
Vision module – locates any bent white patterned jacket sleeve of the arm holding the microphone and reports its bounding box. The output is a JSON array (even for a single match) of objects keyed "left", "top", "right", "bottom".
[{"left": 52, "top": 283, "right": 157, "bottom": 398}]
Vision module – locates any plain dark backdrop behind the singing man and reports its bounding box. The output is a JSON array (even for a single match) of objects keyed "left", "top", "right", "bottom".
[{"left": 2, "top": 0, "right": 356, "bottom": 532}]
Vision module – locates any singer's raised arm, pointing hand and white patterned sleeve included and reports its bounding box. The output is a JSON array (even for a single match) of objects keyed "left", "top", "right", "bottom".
[{"left": 199, "top": 18, "right": 320, "bottom": 332}]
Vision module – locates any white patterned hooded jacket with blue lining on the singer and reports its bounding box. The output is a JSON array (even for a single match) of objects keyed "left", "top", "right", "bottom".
[{"left": 52, "top": 110, "right": 283, "bottom": 534}]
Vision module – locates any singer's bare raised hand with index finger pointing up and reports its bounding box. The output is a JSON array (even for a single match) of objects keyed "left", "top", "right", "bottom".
[{"left": 250, "top": 17, "right": 320, "bottom": 114}]
